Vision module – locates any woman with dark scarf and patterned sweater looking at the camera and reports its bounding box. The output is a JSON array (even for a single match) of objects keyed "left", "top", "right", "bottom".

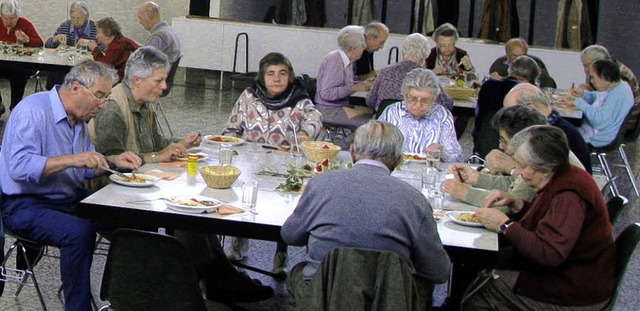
[{"left": 222, "top": 53, "right": 322, "bottom": 148}]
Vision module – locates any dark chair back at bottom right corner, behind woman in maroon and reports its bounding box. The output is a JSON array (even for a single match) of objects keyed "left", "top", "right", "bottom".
[{"left": 604, "top": 223, "right": 640, "bottom": 310}]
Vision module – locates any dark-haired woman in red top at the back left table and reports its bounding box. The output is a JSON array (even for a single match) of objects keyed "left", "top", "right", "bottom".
[{"left": 87, "top": 17, "right": 140, "bottom": 81}]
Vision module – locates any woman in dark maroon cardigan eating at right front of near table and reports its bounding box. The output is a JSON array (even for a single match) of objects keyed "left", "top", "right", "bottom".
[{"left": 463, "top": 125, "right": 616, "bottom": 310}]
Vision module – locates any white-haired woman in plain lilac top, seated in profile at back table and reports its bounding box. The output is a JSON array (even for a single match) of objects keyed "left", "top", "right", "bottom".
[{"left": 315, "top": 26, "right": 373, "bottom": 127}]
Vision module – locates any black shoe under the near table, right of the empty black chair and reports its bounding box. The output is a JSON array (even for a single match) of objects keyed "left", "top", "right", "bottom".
[{"left": 206, "top": 271, "right": 274, "bottom": 303}]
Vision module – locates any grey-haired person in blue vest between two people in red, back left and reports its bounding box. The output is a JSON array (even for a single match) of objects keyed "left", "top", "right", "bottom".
[{"left": 45, "top": 2, "right": 98, "bottom": 48}]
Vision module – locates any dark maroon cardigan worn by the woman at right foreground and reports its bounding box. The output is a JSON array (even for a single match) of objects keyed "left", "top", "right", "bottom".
[{"left": 505, "top": 165, "right": 617, "bottom": 306}]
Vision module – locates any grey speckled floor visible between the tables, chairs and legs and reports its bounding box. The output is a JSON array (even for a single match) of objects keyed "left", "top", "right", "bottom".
[{"left": 0, "top": 68, "right": 640, "bottom": 311}]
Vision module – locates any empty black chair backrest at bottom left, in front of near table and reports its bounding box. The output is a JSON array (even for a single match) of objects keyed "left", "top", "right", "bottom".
[{"left": 100, "top": 229, "right": 206, "bottom": 311}]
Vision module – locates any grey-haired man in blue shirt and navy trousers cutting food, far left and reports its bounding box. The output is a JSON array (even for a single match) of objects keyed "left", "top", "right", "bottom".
[{"left": 0, "top": 60, "right": 142, "bottom": 311}]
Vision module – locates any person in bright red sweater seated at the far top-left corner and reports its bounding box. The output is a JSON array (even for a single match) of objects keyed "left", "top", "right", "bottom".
[{"left": 0, "top": 1, "right": 42, "bottom": 115}]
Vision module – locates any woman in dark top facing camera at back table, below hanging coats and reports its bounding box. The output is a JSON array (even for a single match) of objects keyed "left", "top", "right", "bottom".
[{"left": 426, "top": 23, "right": 475, "bottom": 75}]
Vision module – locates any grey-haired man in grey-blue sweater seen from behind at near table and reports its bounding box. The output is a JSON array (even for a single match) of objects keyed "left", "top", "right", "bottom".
[{"left": 281, "top": 120, "right": 450, "bottom": 304}]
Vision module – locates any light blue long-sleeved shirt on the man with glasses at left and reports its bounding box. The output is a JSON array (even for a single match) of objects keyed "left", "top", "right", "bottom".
[{"left": 0, "top": 86, "right": 95, "bottom": 200}]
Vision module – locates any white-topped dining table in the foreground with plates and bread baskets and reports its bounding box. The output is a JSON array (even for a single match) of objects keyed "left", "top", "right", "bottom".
[{"left": 80, "top": 143, "right": 498, "bottom": 257}]
